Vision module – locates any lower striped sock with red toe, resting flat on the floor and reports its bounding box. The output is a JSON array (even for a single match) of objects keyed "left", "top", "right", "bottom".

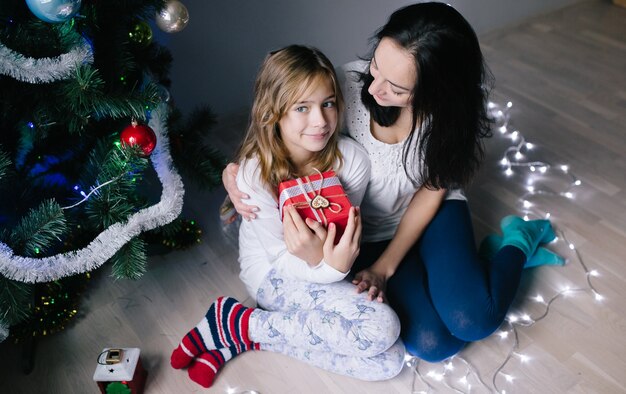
[{"left": 187, "top": 343, "right": 259, "bottom": 388}]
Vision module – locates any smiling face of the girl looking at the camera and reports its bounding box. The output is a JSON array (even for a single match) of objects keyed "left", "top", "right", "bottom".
[{"left": 278, "top": 80, "right": 338, "bottom": 163}]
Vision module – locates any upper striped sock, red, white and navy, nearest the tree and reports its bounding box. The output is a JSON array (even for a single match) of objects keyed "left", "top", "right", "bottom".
[{"left": 170, "top": 297, "right": 254, "bottom": 369}]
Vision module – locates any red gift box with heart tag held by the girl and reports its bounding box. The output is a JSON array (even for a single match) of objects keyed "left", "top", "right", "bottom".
[{"left": 278, "top": 170, "right": 352, "bottom": 243}]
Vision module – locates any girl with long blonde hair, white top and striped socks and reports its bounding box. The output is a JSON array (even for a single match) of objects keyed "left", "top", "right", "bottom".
[{"left": 171, "top": 45, "right": 404, "bottom": 387}]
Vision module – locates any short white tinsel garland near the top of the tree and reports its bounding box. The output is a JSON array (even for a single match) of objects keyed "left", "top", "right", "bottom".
[{"left": 0, "top": 39, "right": 93, "bottom": 83}]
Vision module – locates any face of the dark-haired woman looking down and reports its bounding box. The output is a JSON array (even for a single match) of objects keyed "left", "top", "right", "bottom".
[{"left": 367, "top": 37, "right": 417, "bottom": 108}]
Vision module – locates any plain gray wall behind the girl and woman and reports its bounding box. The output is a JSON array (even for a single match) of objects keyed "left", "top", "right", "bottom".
[{"left": 154, "top": 0, "right": 580, "bottom": 117}]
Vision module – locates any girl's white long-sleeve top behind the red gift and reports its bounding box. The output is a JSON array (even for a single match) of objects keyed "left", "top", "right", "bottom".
[{"left": 237, "top": 137, "right": 370, "bottom": 300}]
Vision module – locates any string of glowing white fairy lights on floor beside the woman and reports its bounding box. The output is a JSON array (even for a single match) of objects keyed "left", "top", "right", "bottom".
[{"left": 405, "top": 102, "right": 604, "bottom": 394}]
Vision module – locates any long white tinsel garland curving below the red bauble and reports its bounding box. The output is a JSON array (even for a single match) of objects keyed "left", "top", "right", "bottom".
[{"left": 0, "top": 104, "right": 185, "bottom": 283}]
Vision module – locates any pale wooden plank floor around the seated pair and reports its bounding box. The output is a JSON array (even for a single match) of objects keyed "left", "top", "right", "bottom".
[{"left": 0, "top": 1, "right": 626, "bottom": 394}]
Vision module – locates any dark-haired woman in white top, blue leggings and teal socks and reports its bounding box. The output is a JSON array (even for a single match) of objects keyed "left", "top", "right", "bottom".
[{"left": 224, "top": 3, "right": 563, "bottom": 362}]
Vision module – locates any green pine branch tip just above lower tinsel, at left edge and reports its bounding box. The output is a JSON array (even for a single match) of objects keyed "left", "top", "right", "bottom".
[{"left": 7, "top": 200, "right": 67, "bottom": 257}]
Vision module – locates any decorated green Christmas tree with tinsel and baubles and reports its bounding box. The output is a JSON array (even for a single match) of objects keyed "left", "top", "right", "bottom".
[{"left": 0, "top": 0, "right": 224, "bottom": 341}]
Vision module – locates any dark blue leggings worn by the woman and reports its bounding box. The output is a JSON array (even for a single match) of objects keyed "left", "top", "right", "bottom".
[{"left": 352, "top": 200, "right": 526, "bottom": 362}]
